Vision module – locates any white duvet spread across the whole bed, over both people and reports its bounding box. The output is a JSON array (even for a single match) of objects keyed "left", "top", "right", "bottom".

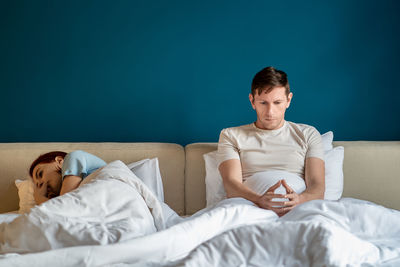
[{"left": 0, "top": 161, "right": 400, "bottom": 266}]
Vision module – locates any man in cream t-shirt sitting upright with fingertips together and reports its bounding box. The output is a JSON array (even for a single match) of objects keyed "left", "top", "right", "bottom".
[{"left": 218, "top": 67, "right": 325, "bottom": 216}]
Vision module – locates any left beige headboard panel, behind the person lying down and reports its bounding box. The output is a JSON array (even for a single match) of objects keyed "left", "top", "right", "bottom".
[{"left": 0, "top": 143, "right": 185, "bottom": 215}]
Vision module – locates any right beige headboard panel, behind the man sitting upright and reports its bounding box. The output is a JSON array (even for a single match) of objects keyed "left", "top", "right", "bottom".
[{"left": 185, "top": 141, "right": 400, "bottom": 214}]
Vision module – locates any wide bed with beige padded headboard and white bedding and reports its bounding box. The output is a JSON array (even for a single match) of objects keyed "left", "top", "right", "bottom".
[{"left": 0, "top": 141, "right": 400, "bottom": 266}]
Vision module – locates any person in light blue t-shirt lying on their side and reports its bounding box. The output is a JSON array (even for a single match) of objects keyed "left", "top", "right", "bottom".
[{"left": 29, "top": 150, "right": 106, "bottom": 204}]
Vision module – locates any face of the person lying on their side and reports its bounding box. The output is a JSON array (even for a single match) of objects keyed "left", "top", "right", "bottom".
[{"left": 32, "top": 160, "right": 62, "bottom": 198}]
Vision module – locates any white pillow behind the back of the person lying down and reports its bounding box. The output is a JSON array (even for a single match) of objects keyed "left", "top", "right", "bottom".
[{"left": 128, "top": 158, "right": 164, "bottom": 202}]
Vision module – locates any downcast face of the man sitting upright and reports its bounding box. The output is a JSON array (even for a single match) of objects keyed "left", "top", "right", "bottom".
[{"left": 249, "top": 87, "right": 293, "bottom": 130}]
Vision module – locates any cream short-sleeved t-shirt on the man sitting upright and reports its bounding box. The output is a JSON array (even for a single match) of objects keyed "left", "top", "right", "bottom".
[{"left": 218, "top": 121, "right": 324, "bottom": 181}]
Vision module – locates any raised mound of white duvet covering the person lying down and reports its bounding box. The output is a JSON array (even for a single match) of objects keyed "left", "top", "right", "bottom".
[{"left": 0, "top": 161, "right": 164, "bottom": 253}]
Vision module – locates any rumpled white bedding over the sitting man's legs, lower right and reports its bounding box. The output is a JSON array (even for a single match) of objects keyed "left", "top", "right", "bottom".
[{"left": 170, "top": 198, "right": 400, "bottom": 266}]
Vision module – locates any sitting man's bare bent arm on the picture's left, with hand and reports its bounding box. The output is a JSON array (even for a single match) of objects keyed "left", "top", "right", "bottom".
[{"left": 218, "top": 159, "right": 284, "bottom": 212}]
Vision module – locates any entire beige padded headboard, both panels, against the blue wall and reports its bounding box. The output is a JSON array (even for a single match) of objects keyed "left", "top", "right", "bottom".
[{"left": 0, "top": 141, "right": 400, "bottom": 215}]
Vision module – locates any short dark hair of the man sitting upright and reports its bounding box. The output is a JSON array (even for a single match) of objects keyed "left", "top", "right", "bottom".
[{"left": 251, "top": 67, "right": 290, "bottom": 96}]
